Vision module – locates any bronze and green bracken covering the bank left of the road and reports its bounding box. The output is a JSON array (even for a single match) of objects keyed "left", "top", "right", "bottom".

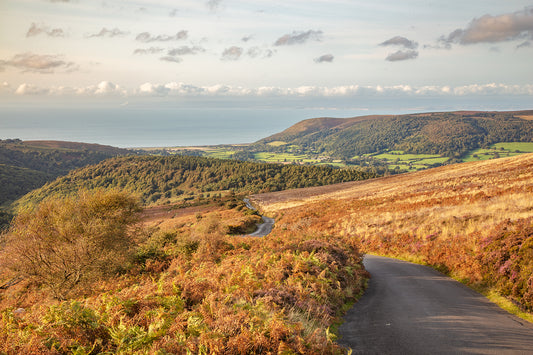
[{"left": 0, "top": 193, "right": 367, "bottom": 354}]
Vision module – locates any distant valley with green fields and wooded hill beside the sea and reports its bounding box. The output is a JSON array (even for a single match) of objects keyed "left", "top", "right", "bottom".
[{"left": 152, "top": 111, "right": 533, "bottom": 174}]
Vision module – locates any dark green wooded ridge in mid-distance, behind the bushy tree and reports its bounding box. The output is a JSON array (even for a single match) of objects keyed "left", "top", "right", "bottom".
[{"left": 18, "top": 155, "right": 374, "bottom": 206}]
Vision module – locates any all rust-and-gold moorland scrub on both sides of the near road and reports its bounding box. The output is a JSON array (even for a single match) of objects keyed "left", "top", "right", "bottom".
[{"left": 4, "top": 154, "right": 533, "bottom": 354}]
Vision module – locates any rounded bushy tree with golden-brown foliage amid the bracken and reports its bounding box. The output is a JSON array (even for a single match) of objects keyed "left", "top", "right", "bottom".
[{"left": 4, "top": 190, "right": 140, "bottom": 299}]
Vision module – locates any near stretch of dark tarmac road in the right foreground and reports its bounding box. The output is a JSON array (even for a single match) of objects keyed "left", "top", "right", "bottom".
[{"left": 339, "top": 255, "right": 533, "bottom": 354}]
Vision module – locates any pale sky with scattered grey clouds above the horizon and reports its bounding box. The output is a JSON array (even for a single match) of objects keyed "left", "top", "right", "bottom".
[{"left": 0, "top": 0, "right": 533, "bottom": 146}]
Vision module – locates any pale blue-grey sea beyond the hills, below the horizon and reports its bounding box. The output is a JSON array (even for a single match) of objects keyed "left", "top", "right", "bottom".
[{"left": 0, "top": 107, "right": 374, "bottom": 148}]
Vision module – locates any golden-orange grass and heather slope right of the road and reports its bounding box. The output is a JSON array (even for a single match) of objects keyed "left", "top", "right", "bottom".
[{"left": 252, "top": 154, "right": 533, "bottom": 312}]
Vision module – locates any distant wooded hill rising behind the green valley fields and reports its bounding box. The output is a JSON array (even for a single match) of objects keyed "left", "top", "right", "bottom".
[{"left": 248, "top": 111, "right": 533, "bottom": 162}]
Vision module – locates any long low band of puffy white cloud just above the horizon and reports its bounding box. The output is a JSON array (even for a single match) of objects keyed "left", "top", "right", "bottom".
[{"left": 2, "top": 81, "right": 533, "bottom": 98}]
